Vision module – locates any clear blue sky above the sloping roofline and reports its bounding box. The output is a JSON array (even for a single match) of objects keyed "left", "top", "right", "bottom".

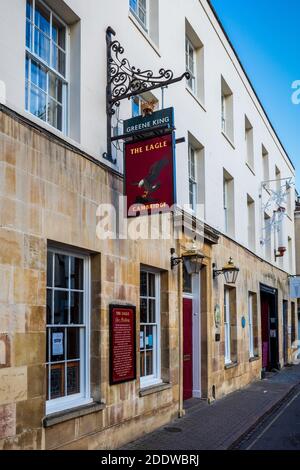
[{"left": 212, "top": 0, "right": 300, "bottom": 190}]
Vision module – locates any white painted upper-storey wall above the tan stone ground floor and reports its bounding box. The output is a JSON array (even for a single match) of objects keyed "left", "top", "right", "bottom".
[{"left": 0, "top": 0, "right": 295, "bottom": 270}]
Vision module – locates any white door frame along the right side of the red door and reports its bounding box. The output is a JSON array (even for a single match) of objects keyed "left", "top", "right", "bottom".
[{"left": 182, "top": 274, "right": 202, "bottom": 398}]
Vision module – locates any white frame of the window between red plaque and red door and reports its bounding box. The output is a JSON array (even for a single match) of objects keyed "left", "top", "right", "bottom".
[{"left": 139, "top": 266, "right": 162, "bottom": 389}]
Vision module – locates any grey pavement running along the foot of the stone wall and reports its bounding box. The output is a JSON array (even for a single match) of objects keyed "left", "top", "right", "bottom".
[{"left": 122, "top": 365, "right": 300, "bottom": 451}]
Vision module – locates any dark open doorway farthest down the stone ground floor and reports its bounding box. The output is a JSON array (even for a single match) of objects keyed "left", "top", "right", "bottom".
[{"left": 260, "top": 285, "right": 280, "bottom": 371}]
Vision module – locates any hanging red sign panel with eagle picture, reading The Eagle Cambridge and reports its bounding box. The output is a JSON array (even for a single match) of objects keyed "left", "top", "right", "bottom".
[{"left": 125, "top": 134, "right": 175, "bottom": 217}]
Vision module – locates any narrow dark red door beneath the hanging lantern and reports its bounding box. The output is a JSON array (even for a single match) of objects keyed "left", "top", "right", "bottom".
[{"left": 183, "top": 299, "right": 193, "bottom": 400}]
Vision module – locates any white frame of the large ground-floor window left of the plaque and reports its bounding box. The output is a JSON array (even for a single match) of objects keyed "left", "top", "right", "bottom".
[{"left": 45, "top": 247, "right": 93, "bottom": 415}]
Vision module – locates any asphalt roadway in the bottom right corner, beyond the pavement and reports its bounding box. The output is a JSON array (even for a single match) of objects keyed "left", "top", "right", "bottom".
[{"left": 233, "top": 386, "right": 300, "bottom": 450}]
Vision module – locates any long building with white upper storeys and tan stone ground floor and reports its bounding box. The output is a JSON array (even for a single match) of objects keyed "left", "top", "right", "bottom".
[{"left": 0, "top": 0, "right": 297, "bottom": 449}]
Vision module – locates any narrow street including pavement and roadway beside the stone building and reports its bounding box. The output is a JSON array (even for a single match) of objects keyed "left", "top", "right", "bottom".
[{"left": 123, "top": 365, "right": 300, "bottom": 450}]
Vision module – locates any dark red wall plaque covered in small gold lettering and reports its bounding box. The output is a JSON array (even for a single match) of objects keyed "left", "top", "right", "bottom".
[{"left": 109, "top": 305, "right": 136, "bottom": 385}]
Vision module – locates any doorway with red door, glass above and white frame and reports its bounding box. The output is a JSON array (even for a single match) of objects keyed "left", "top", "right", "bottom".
[{"left": 183, "top": 268, "right": 201, "bottom": 400}]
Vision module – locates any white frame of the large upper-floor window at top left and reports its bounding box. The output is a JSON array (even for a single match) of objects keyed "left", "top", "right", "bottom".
[{"left": 25, "top": 0, "right": 70, "bottom": 135}]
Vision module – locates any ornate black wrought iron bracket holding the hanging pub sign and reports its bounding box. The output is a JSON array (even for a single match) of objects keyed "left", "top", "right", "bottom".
[{"left": 103, "top": 26, "right": 190, "bottom": 165}]
